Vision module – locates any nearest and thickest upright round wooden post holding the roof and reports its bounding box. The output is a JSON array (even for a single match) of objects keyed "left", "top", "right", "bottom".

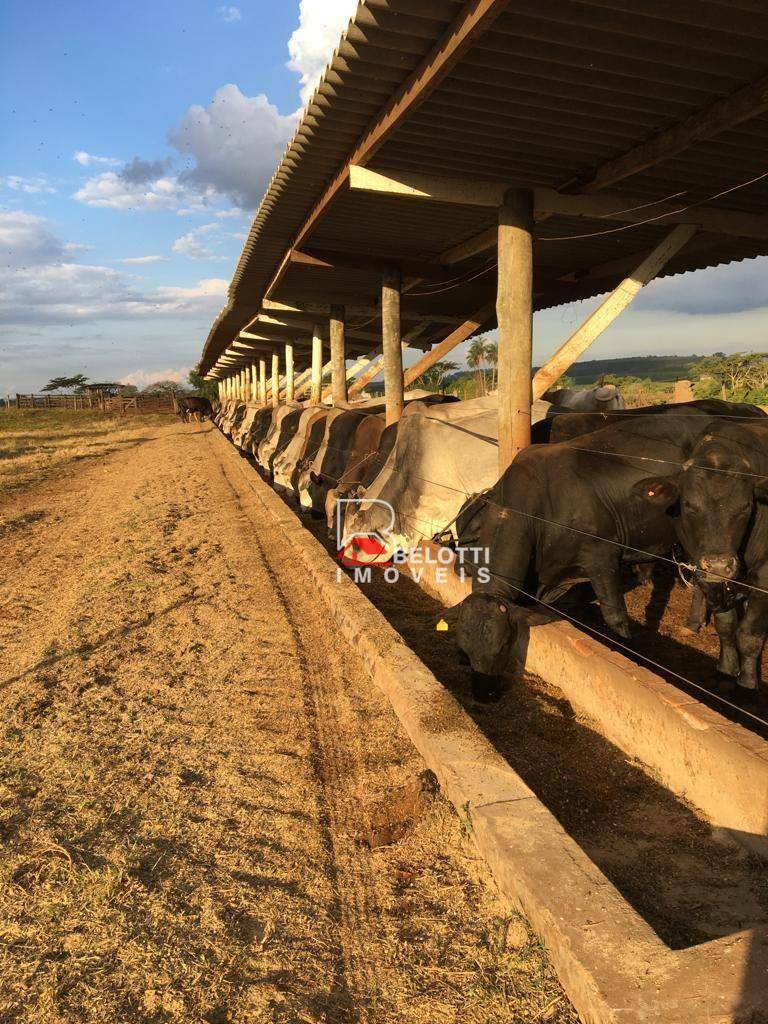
[{"left": 496, "top": 188, "right": 534, "bottom": 475}]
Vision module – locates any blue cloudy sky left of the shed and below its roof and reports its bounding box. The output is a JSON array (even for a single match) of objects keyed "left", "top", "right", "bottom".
[{"left": 0, "top": 0, "right": 768, "bottom": 393}]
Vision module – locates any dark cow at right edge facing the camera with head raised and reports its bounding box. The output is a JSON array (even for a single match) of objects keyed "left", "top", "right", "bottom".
[{"left": 638, "top": 419, "right": 768, "bottom": 698}]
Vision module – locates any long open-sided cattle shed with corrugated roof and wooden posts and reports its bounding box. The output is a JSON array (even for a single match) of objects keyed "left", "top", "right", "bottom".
[{"left": 201, "top": 0, "right": 768, "bottom": 469}]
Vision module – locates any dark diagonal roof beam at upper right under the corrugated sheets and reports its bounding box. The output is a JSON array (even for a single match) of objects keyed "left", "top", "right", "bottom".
[{"left": 561, "top": 75, "right": 768, "bottom": 195}]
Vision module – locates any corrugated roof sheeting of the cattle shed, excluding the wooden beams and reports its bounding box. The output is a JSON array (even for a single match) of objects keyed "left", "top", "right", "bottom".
[{"left": 202, "top": 0, "right": 768, "bottom": 372}]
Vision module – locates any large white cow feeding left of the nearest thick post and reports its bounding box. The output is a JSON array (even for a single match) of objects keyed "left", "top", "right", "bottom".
[{"left": 344, "top": 395, "right": 549, "bottom": 551}]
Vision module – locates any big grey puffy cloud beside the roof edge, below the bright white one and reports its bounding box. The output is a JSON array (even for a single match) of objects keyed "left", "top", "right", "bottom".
[{"left": 169, "top": 85, "right": 296, "bottom": 209}]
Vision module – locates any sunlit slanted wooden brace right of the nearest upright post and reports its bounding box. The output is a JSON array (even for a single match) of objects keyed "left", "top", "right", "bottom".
[{"left": 532, "top": 224, "right": 696, "bottom": 399}]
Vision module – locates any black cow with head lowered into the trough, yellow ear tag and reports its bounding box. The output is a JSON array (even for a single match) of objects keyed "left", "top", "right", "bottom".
[{"left": 449, "top": 407, "right": 765, "bottom": 698}]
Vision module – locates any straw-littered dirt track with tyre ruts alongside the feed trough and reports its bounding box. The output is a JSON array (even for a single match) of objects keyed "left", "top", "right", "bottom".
[{"left": 0, "top": 424, "right": 575, "bottom": 1024}]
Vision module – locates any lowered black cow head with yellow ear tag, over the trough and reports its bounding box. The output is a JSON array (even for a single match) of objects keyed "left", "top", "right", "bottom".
[{"left": 441, "top": 591, "right": 554, "bottom": 702}]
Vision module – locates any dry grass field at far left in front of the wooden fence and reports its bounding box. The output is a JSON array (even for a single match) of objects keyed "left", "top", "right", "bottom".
[{"left": 0, "top": 409, "right": 170, "bottom": 495}]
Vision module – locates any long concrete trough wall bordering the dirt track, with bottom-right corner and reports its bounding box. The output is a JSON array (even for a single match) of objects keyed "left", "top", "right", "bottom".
[{"left": 221, "top": 438, "right": 768, "bottom": 1024}]
